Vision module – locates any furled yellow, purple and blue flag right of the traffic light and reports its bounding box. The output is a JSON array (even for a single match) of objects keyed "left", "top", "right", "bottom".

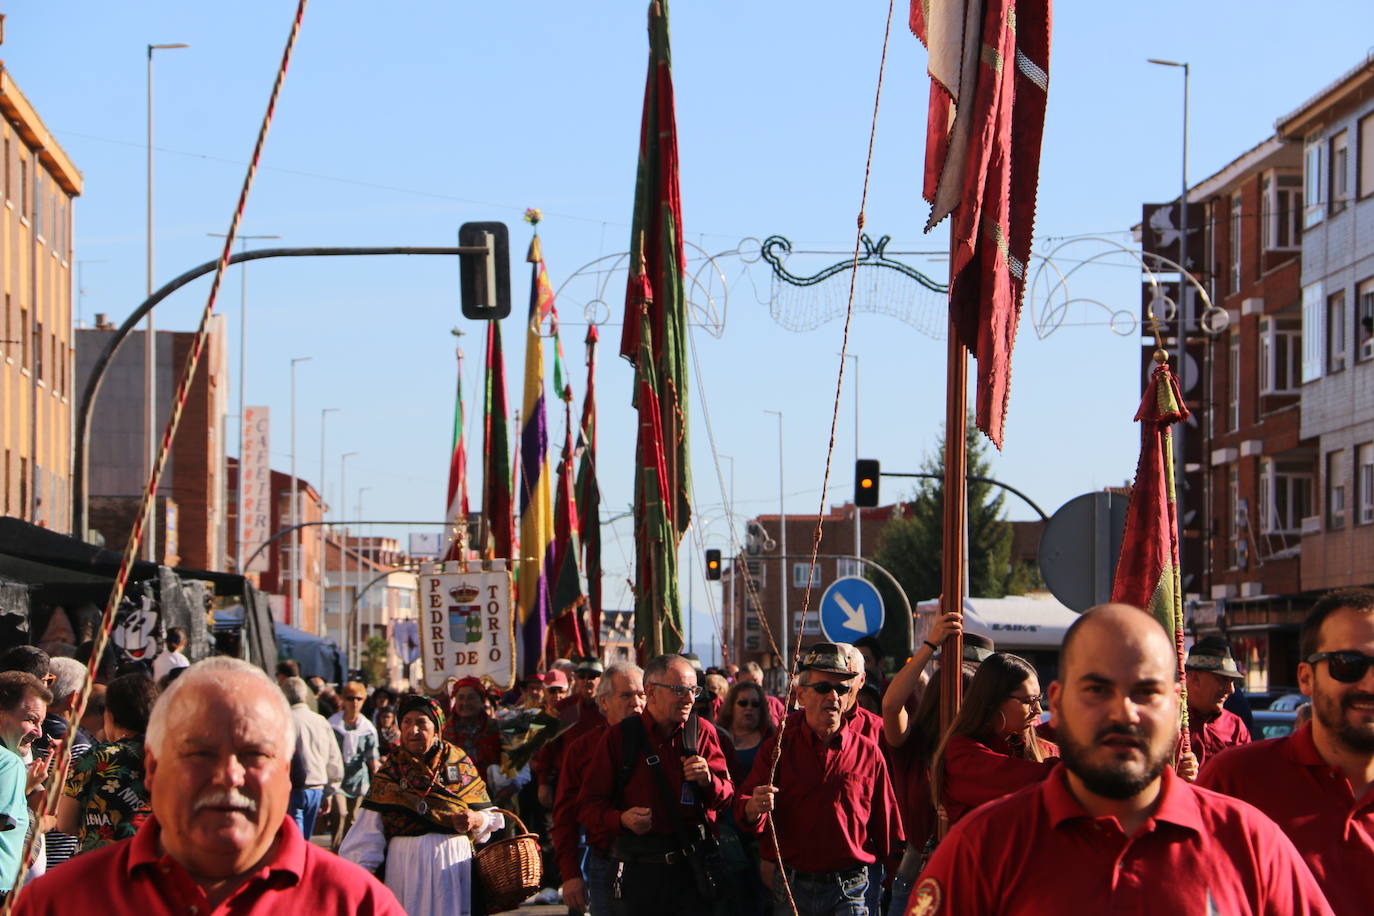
[{"left": 518, "top": 233, "right": 554, "bottom": 674}]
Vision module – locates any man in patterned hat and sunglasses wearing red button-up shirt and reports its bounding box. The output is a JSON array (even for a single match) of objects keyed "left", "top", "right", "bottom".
[{"left": 735, "top": 643, "right": 903, "bottom": 916}]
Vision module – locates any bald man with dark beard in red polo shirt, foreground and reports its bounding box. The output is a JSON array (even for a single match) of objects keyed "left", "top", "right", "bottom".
[{"left": 907, "top": 604, "right": 1331, "bottom": 916}]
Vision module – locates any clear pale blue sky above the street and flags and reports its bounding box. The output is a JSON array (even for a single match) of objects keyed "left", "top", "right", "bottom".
[{"left": 0, "top": 0, "right": 1369, "bottom": 654}]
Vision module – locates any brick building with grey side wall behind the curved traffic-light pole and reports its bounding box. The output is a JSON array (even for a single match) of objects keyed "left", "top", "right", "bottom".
[{"left": 76, "top": 314, "right": 234, "bottom": 571}]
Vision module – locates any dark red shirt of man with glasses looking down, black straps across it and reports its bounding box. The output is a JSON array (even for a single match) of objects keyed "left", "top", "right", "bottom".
[{"left": 577, "top": 710, "right": 735, "bottom": 838}]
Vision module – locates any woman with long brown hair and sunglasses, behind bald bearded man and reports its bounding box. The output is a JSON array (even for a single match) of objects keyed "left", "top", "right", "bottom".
[{"left": 930, "top": 652, "right": 1059, "bottom": 824}]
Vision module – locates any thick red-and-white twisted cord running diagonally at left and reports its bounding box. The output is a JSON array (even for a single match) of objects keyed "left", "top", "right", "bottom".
[{"left": 0, "top": 0, "right": 309, "bottom": 916}]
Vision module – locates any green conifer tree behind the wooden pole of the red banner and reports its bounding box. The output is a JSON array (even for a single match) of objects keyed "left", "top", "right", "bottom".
[{"left": 871, "top": 417, "right": 1039, "bottom": 656}]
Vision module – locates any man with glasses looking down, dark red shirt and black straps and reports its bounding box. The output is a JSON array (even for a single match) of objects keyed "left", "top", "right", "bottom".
[{"left": 577, "top": 655, "right": 735, "bottom": 916}]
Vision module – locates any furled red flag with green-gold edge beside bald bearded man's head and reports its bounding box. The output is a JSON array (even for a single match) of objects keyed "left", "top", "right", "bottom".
[{"left": 1112, "top": 354, "right": 1189, "bottom": 750}]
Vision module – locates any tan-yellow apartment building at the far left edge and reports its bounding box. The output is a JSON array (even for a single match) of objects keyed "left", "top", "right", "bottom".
[{"left": 0, "top": 63, "right": 81, "bottom": 533}]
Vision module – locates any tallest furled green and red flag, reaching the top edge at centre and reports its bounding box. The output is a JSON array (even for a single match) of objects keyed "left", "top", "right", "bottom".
[{"left": 620, "top": 0, "right": 691, "bottom": 656}]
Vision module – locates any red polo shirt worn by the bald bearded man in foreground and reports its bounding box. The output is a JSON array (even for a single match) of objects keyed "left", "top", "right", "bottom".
[{"left": 907, "top": 766, "right": 1331, "bottom": 916}]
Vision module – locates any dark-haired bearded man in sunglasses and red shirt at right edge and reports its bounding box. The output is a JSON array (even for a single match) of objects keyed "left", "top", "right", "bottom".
[{"left": 1198, "top": 588, "right": 1374, "bottom": 915}]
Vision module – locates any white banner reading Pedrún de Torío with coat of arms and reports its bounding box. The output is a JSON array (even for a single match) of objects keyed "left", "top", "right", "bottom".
[{"left": 419, "top": 562, "right": 515, "bottom": 691}]
